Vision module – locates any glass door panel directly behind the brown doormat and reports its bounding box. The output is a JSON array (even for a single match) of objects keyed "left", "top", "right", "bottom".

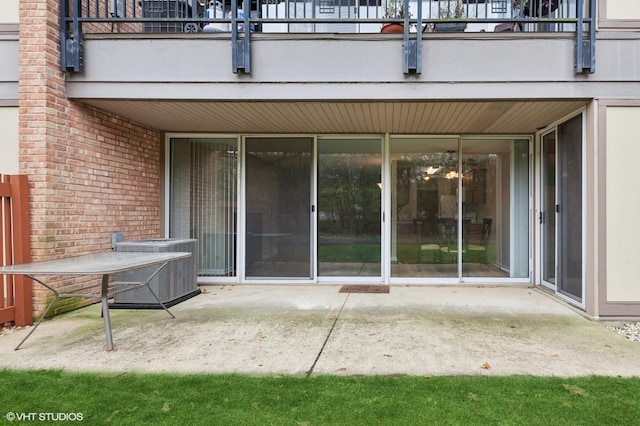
[{"left": 317, "top": 138, "right": 382, "bottom": 277}]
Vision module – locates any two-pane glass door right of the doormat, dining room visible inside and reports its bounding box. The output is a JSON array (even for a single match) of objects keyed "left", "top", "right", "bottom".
[{"left": 390, "top": 137, "right": 531, "bottom": 281}]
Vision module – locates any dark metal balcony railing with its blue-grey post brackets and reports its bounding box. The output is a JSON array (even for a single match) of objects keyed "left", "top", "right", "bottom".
[{"left": 60, "top": 0, "right": 597, "bottom": 73}]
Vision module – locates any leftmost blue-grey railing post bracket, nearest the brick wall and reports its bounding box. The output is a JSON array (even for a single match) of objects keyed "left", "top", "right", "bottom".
[{"left": 60, "top": 0, "right": 84, "bottom": 72}]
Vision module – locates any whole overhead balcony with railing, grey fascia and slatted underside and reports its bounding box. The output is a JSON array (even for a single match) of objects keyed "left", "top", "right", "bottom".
[{"left": 61, "top": 0, "right": 608, "bottom": 134}]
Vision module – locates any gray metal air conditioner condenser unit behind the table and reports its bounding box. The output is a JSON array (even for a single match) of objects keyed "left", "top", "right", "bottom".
[{"left": 110, "top": 238, "right": 200, "bottom": 309}]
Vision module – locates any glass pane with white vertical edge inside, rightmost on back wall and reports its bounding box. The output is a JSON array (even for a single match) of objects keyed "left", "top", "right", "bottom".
[{"left": 461, "top": 139, "right": 529, "bottom": 278}]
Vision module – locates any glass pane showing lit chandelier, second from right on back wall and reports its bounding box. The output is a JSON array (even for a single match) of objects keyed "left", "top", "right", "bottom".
[{"left": 391, "top": 138, "right": 459, "bottom": 278}]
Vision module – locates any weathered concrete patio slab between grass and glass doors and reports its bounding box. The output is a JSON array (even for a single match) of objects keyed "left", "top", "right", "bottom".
[{"left": 0, "top": 285, "right": 640, "bottom": 376}]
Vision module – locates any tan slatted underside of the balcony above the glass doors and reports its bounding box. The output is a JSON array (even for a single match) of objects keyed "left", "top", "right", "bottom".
[{"left": 81, "top": 100, "right": 586, "bottom": 134}]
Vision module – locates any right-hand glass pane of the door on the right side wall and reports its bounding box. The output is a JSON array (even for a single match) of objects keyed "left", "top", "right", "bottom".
[{"left": 557, "top": 115, "right": 582, "bottom": 301}]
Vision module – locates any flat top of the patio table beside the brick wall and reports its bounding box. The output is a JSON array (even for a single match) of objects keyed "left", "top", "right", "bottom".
[{"left": 0, "top": 252, "right": 191, "bottom": 275}]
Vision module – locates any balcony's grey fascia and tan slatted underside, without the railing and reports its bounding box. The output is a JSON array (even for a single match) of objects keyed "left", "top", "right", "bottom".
[{"left": 62, "top": 34, "right": 640, "bottom": 134}]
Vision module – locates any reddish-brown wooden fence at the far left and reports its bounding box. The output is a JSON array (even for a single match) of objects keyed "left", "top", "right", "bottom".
[{"left": 0, "top": 175, "right": 33, "bottom": 327}]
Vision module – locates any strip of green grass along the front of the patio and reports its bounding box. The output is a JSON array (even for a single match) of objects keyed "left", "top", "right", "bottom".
[{"left": 0, "top": 370, "right": 640, "bottom": 426}]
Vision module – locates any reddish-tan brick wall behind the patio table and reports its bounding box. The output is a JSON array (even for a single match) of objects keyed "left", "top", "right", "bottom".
[{"left": 19, "top": 0, "right": 161, "bottom": 315}]
